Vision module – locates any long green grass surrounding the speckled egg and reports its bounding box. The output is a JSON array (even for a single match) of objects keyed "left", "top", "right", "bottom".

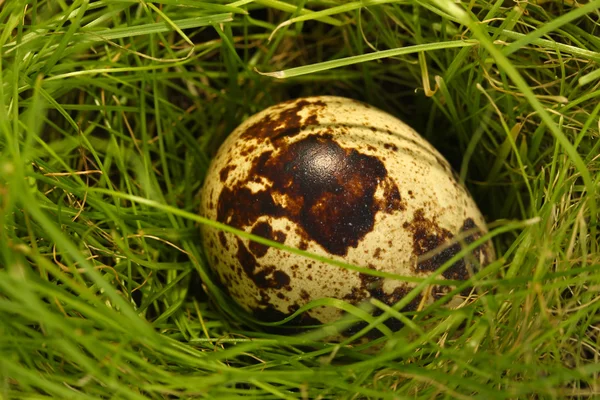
[{"left": 0, "top": 0, "right": 600, "bottom": 400}]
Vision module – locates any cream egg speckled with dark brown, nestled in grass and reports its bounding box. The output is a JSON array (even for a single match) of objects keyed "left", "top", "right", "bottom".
[{"left": 201, "top": 96, "right": 494, "bottom": 332}]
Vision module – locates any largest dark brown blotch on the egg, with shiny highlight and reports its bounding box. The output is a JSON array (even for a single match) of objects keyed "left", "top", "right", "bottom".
[{"left": 217, "top": 134, "right": 405, "bottom": 255}]
